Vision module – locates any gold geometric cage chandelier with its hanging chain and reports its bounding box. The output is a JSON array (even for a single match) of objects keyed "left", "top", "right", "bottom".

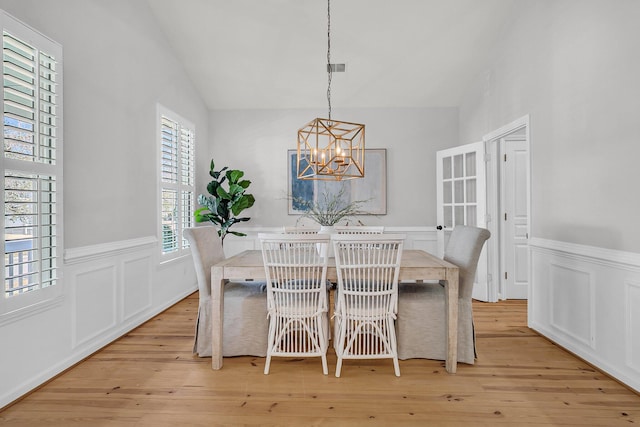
[{"left": 297, "top": 0, "right": 365, "bottom": 181}]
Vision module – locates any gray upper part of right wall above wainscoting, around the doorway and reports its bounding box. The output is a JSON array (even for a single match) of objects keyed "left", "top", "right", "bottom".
[{"left": 460, "top": 0, "right": 640, "bottom": 253}]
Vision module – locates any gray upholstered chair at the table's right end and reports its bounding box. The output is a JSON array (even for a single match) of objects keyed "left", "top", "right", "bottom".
[{"left": 396, "top": 225, "right": 491, "bottom": 364}]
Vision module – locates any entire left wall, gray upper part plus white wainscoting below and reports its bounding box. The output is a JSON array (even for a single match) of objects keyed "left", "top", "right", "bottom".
[{"left": 0, "top": 0, "right": 208, "bottom": 408}]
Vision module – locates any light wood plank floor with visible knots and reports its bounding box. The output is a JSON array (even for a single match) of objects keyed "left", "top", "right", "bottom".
[{"left": 0, "top": 294, "right": 640, "bottom": 427}]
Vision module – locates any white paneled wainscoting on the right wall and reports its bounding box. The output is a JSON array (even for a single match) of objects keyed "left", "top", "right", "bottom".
[{"left": 529, "top": 238, "right": 640, "bottom": 391}]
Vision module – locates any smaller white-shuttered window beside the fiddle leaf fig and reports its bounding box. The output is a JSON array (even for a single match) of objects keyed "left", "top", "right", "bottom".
[{"left": 158, "top": 106, "right": 195, "bottom": 258}]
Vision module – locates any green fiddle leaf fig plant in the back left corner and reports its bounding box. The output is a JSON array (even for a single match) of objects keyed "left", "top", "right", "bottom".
[{"left": 194, "top": 160, "right": 256, "bottom": 243}]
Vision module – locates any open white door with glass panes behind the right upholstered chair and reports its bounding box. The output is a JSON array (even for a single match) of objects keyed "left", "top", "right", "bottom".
[{"left": 436, "top": 142, "right": 488, "bottom": 301}]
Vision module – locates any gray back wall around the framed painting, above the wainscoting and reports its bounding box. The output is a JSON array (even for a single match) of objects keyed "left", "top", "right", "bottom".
[{"left": 208, "top": 108, "right": 458, "bottom": 226}]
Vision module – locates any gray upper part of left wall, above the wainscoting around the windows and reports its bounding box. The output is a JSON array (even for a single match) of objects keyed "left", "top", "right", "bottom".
[{"left": 0, "top": 0, "right": 208, "bottom": 248}]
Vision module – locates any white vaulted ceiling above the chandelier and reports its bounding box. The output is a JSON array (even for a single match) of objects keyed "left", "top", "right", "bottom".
[{"left": 147, "top": 0, "right": 519, "bottom": 110}]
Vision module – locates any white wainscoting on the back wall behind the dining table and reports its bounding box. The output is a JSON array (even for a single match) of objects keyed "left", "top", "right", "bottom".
[{"left": 224, "top": 226, "right": 438, "bottom": 257}]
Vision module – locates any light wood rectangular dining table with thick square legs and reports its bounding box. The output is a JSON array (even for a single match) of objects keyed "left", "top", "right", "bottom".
[{"left": 211, "top": 249, "right": 459, "bottom": 374}]
